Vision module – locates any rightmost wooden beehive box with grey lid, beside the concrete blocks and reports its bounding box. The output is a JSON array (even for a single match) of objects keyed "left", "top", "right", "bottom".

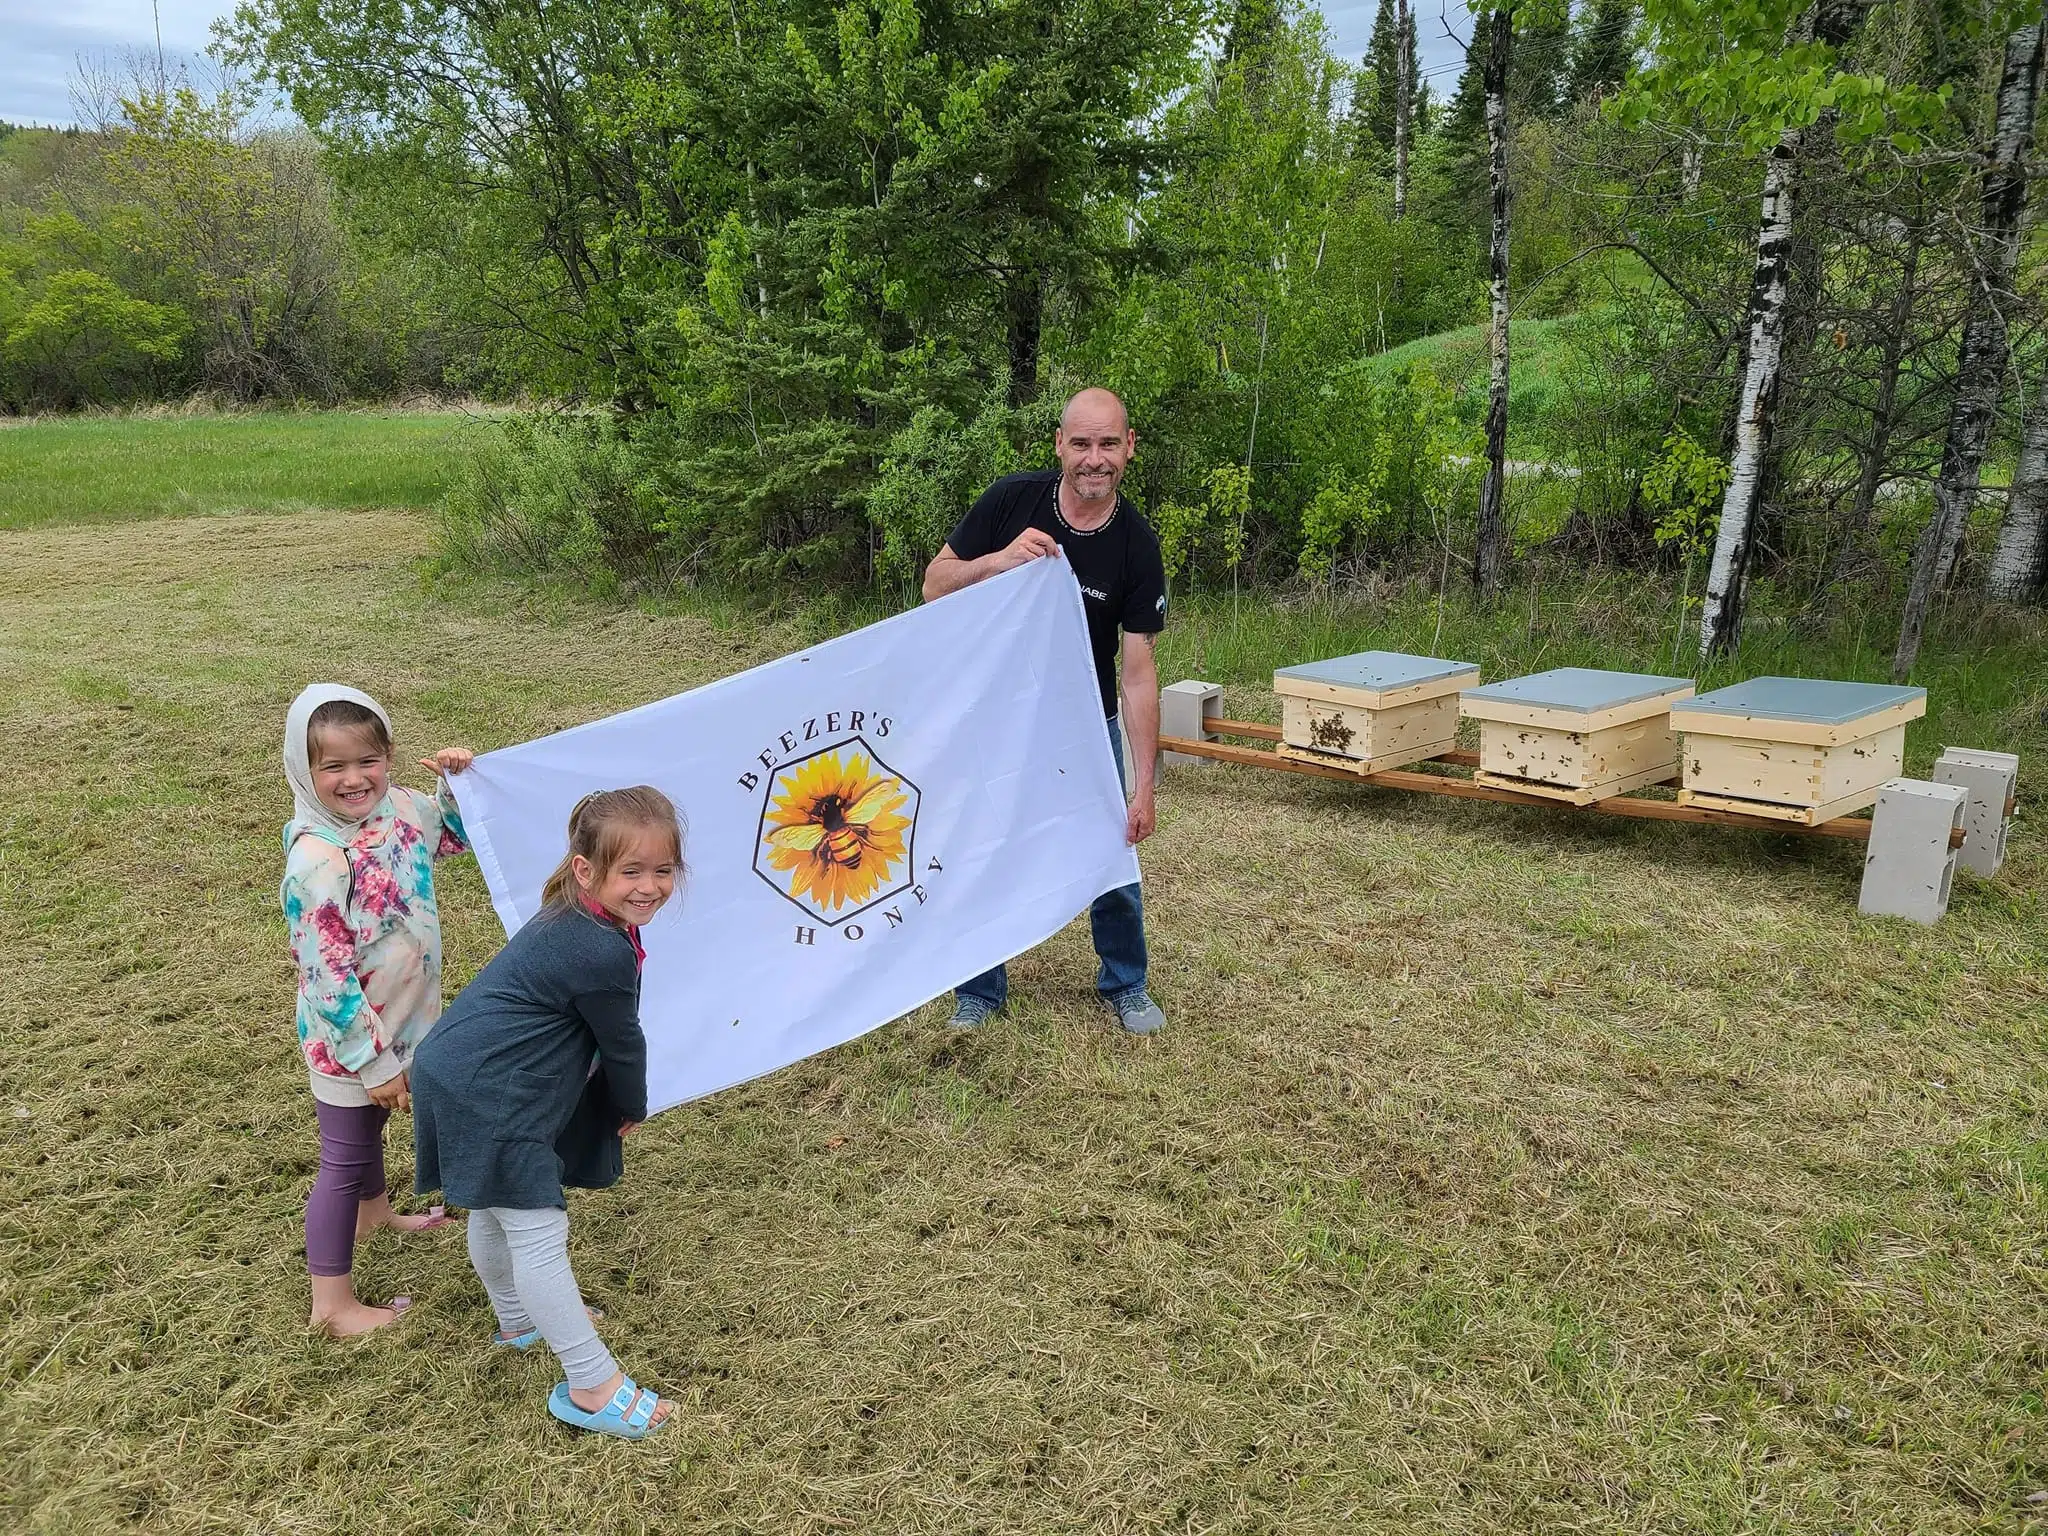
[{"left": 1671, "top": 678, "right": 1927, "bottom": 827}]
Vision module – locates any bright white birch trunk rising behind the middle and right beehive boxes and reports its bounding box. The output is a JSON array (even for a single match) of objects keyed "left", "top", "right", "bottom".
[{"left": 1700, "top": 127, "right": 1804, "bottom": 659}]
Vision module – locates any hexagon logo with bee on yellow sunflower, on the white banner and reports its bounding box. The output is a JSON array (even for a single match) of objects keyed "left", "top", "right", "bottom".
[{"left": 754, "top": 737, "right": 918, "bottom": 924}]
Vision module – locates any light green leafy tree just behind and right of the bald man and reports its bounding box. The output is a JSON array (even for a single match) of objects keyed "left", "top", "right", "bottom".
[{"left": 1055, "top": 12, "right": 1475, "bottom": 580}]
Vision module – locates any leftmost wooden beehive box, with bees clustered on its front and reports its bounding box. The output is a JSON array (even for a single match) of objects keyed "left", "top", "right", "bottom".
[{"left": 1274, "top": 651, "right": 1479, "bottom": 774}]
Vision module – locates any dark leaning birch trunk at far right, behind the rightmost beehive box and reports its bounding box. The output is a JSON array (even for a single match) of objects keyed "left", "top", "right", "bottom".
[{"left": 1892, "top": 14, "right": 2048, "bottom": 682}]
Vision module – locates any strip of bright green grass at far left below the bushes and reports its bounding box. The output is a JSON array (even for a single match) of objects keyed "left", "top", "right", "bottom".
[{"left": 0, "top": 410, "right": 475, "bottom": 528}]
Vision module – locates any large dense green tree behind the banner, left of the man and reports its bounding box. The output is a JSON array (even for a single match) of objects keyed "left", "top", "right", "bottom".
[{"left": 240, "top": 0, "right": 1212, "bottom": 573}]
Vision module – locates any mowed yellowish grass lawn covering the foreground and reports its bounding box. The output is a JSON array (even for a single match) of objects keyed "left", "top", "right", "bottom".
[{"left": 0, "top": 415, "right": 2048, "bottom": 1536}]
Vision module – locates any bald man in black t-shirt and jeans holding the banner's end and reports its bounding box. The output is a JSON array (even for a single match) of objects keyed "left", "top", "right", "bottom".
[{"left": 924, "top": 389, "right": 1165, "bottom": 1034}]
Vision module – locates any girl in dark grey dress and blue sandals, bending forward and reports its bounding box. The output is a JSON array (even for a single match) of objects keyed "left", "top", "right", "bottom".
[{"left": 412, "top": 784, "right": 684, "bottom": 1440}]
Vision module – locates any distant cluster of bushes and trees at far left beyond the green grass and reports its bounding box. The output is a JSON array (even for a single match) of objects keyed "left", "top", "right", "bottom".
[{"left": 0, "top": 66, "right": 451, "bottom": 412}]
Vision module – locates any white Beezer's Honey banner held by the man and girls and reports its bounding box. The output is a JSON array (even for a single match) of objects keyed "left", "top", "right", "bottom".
[{"left": 453, "top": 559, "right": 1139, "bottom": 1108}]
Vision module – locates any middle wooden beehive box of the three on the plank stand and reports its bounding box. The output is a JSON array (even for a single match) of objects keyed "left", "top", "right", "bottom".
[{"left": 1458, "top": 668, "right": 1692, "bottom": 805}]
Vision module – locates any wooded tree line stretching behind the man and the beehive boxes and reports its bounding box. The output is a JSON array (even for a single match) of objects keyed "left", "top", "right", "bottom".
[{"left": 0, "top": 0, "right": 2048, "bottom": 672}]
